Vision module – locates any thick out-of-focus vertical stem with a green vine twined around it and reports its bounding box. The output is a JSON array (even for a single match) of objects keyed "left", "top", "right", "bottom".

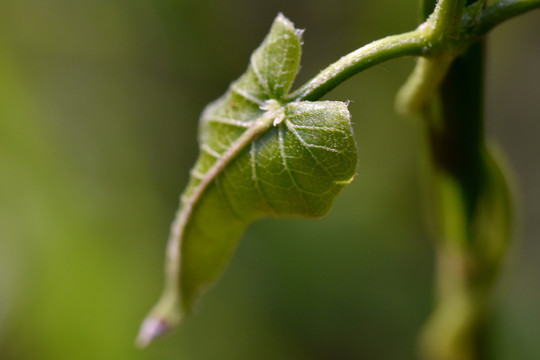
[{"left": 404, "top": 1, "right": 511, "bottom": 360}]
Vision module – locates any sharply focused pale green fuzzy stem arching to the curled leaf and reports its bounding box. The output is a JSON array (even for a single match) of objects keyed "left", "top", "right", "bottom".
[{"left": 294, "top": 0, "right": 540, "bottom": 105}]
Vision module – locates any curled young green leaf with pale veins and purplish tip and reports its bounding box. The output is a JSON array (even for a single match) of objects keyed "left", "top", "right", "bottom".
[{"left": 138, "top": 14, "right": 357, "bottom": 346}]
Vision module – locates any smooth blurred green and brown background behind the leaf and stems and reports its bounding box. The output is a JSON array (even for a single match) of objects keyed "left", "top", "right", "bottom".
[{"left": 0, "top": 0, "right": 540, "bottom": 360}]
